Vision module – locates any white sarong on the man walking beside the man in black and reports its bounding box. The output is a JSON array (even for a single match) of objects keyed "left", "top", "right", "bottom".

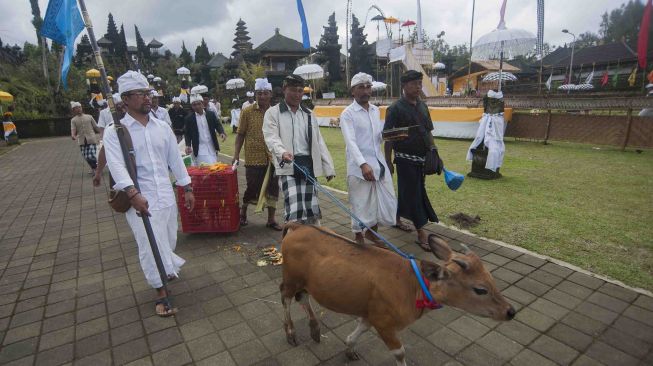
[{"left": 347, "top": 171, "right": 397, "bottom": 233}]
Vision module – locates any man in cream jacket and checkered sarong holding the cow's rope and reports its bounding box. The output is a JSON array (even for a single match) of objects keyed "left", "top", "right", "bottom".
[{"left": 263, "top": 75, "right": 336, "bottom": 225}]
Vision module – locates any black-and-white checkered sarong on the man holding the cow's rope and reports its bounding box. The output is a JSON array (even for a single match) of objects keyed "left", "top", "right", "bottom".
[{"left": 279, "top": 175, "right": 322, "bottom": 224}]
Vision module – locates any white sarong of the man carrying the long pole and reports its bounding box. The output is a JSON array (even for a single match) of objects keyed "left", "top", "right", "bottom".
[{"left": 125, "top": 205, "right": 186, "bottom": 288}]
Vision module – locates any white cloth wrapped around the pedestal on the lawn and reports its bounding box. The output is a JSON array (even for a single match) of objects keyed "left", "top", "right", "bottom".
[{"left": 467, "top": 113, "right": 506, "bottom": 172}]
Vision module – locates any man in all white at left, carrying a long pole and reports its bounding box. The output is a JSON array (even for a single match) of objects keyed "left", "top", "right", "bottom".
[{"left": 104, "top": 71, "right": 195, "bottom": 316}]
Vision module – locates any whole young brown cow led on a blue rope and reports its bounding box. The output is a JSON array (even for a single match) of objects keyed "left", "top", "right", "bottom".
[{"left": 280, "top": 223, "right": 515, "bottom": 366}]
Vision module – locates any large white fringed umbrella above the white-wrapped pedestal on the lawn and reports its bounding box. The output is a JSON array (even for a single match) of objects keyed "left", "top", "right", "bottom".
[{"left": 472, "top": 2, "right": 537, "bottom": 91}]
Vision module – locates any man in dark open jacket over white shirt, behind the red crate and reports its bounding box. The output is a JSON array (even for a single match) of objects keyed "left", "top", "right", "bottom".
[{"left": 184, "top": 94, "right": 227, "bottom": 166}]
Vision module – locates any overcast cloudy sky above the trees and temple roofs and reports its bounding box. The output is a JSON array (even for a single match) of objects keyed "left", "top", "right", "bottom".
[{"left": 0, "top": 0, "right": 625, "bottom": 55}]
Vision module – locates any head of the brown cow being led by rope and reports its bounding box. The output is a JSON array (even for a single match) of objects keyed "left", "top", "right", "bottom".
[{"left": 422, "top": 235, "right": 515, "bottom": 320}]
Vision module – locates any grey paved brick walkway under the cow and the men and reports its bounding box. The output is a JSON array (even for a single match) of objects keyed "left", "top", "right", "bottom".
[{"left": 0, "top": 138, "right": 653, "bottom": 366}]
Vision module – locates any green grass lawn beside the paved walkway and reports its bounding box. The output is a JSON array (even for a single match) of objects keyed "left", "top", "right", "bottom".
[{"left": 222, "top": 128, "right": 653, "bottom": 290}]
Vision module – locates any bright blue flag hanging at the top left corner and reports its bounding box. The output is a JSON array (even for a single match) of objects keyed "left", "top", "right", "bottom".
[{"left": 41, "top": 0, "right": 84, "bottom": 89}]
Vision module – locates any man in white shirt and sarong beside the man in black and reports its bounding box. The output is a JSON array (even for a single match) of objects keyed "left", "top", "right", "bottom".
[{"left": 340, "top": 72, "right": 397, "bottom": 245}]
